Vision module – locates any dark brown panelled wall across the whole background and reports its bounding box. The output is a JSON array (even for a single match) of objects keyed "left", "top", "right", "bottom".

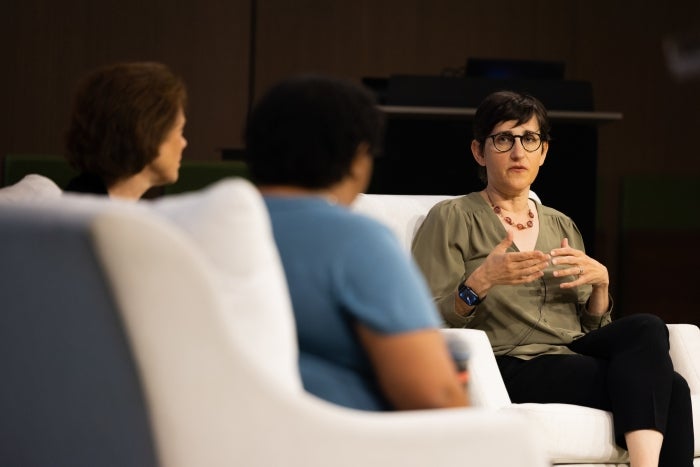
[{"left": 0, "top": 0, "right": 700, "bottom": 322}]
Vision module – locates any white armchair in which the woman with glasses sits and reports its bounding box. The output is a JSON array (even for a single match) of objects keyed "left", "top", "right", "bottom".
[{"left": 353, "top": 193, "right": 700, "bottom": 467}]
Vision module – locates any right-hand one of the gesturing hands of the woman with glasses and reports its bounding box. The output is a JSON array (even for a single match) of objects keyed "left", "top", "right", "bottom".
[{"left": 550, "top": 238, "right": 610, "bottom": 289}]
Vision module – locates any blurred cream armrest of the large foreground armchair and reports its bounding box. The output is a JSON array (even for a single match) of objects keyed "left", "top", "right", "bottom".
[{"left": 288, "top": 398, "right": 550, "bottom": 467}]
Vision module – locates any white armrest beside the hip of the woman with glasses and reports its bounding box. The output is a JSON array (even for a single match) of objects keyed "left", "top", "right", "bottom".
[{"left": 441, "top": 328, "right": 511, "bottom": 409}]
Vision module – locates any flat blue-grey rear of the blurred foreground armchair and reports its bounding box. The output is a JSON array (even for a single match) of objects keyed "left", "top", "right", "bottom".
[{"left": 0, "top": 203, "right": 158, "bottom": 467}]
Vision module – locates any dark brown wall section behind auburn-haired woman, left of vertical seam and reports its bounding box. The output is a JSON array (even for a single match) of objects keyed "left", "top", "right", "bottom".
[{"left": 0, "top": 0, "right": 250, "bottom": 163}]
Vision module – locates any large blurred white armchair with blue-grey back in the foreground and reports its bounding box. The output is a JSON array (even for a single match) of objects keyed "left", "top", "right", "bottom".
[{"left": 0, "top": 179, "right": 549, "bottom": 467}]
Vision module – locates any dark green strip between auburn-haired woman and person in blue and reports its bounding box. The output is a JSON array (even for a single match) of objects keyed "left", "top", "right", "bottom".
[{"left": 163, "top": 161, "right": 248, "bottom": 195}]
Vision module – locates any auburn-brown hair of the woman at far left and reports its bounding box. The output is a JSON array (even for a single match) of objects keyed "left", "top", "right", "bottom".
[{"left": 65, "top": 62, "right": 187, "bottom": 185}]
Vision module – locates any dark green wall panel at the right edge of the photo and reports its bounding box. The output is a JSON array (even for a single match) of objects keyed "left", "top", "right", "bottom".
[{"left": 620, "top": 174, "right": 700, "bottom": 230}]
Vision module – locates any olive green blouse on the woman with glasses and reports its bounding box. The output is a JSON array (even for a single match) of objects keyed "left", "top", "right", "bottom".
[{"left": 412, "top": 192, "right": 612, "bottom": 358}]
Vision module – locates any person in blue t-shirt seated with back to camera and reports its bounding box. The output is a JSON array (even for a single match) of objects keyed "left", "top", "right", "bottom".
[{"left": 245, "top": 76, "right": 468, "bottom": 411}]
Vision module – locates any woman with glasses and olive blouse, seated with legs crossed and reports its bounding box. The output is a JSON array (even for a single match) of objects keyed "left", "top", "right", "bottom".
[{"left": 413, "top": 91, "right": 693, "bottom": 467}]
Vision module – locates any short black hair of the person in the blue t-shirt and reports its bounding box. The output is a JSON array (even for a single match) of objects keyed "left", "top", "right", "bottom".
[{"left": 244, "top": 74, "right": 384, "bottom": 189}]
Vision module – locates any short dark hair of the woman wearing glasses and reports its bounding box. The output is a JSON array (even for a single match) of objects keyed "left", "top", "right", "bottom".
[{"left": 473, "top": 90, "right": 550, "bottom": 183}]
